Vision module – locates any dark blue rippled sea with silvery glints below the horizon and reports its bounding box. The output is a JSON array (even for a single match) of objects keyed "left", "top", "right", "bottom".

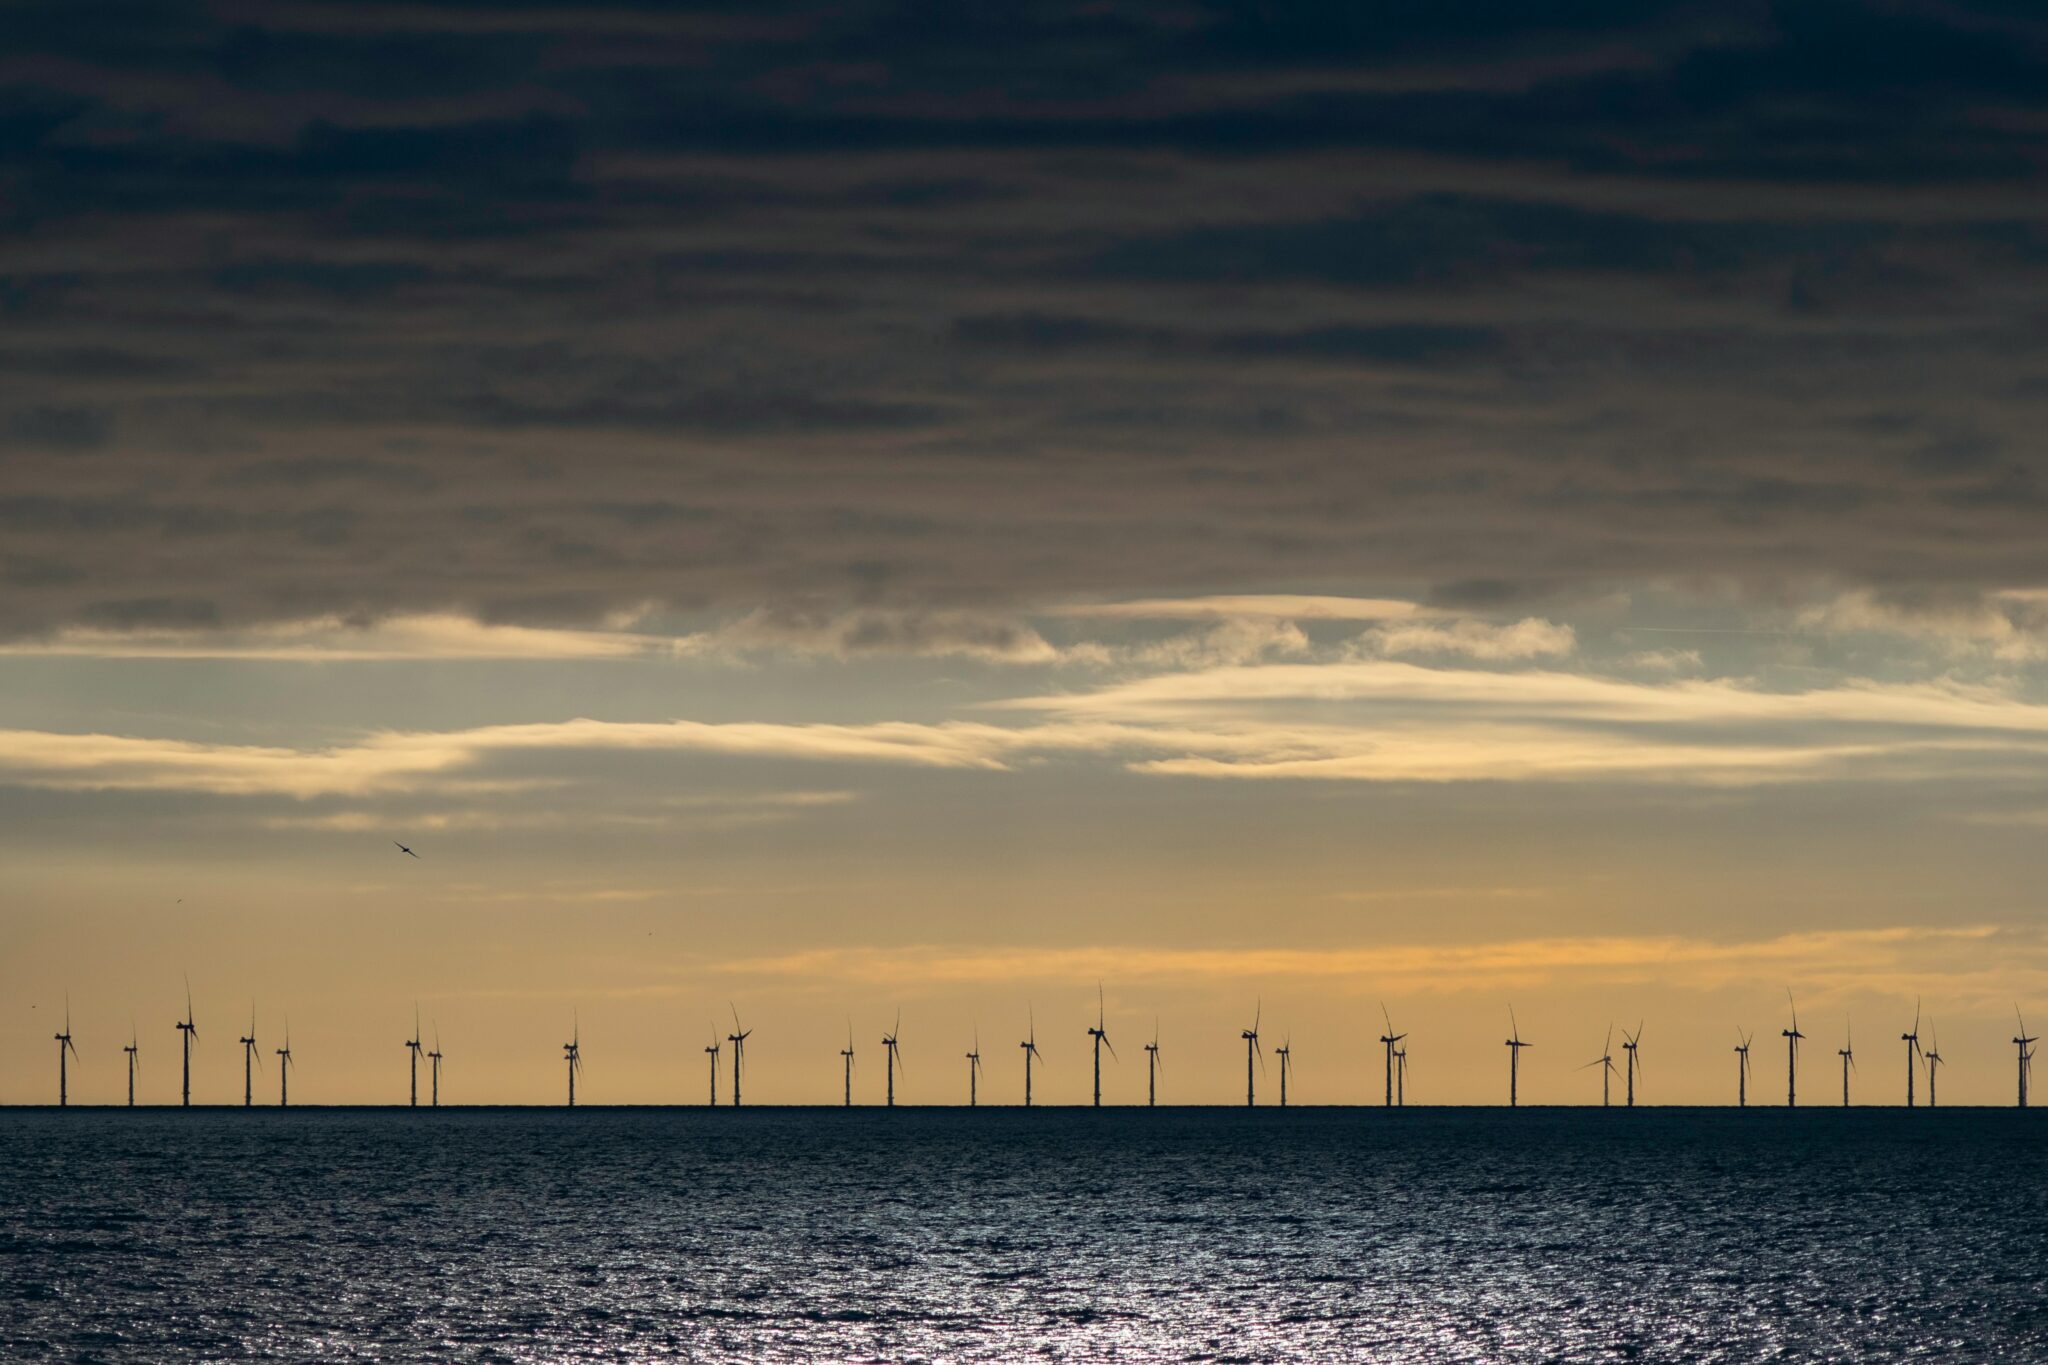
[{"left": 0, "top": 1107, "right": 2048, "bottom": 1361}]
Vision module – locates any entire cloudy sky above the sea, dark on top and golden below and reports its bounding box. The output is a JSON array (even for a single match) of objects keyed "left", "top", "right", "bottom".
[{"left": 0, "top": 0, "right": 2048, "bottom": 1103}]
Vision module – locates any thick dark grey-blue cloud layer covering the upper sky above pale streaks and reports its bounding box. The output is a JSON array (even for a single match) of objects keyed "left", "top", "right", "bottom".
[{"left": 0, "top": 0, "right": 2048, "bottom": 634}]
